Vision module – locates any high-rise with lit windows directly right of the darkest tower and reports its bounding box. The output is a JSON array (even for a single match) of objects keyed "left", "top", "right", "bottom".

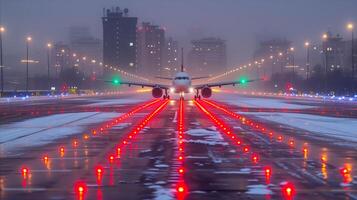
[{"left": 138, "top": 22, "right": 165, "bottom": 76}]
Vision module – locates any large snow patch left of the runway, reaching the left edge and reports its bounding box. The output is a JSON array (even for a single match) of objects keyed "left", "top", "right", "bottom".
[{"left": 0, "top": 112, "right": 121, "bottom": 155}]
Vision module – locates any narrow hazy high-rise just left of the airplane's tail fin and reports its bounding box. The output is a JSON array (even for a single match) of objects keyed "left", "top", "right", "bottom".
[{"left": 163, "top": 37, "right": 180, "bottom": 76}]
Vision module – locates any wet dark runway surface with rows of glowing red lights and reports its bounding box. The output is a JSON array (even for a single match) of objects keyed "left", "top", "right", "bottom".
[{"left": 0, "top": 94, "right": 357, "bottom": 200}]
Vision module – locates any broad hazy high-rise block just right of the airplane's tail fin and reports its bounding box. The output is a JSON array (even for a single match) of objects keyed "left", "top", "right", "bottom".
[{"left": 187, "top": 37, "right": 227, "bottom": 75}]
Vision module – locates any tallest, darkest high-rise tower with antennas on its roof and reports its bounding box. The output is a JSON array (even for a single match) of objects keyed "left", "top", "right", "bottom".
[{"left": 102, "top": 7, "right": 138, "bottom": 76}]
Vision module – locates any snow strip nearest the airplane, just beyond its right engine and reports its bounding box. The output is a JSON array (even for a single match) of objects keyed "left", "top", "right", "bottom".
[{"left": 217, "top": 95, "right": 315, "bottom": 109}]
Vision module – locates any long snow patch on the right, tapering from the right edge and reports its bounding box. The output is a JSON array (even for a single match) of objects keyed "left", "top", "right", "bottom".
[{"left": 245, "top": 112, "right": 357, "bottom": 142}]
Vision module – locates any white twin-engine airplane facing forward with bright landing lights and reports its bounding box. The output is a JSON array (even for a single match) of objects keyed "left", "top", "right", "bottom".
[{"left": 110, "top": 47, "right": 257, "bottom": 99}]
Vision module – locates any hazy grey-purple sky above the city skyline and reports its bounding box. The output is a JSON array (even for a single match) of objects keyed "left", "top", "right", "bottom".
[{"left": 0, "top": 0, "right": 357, "bottom": 71}]
